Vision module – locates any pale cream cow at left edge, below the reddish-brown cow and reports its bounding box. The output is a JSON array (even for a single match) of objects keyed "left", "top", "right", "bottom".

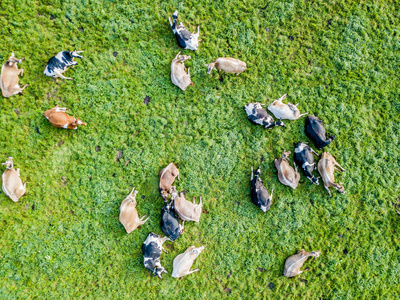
[{"left": 1, "top": 157, "right": 26, "bottom": 202}]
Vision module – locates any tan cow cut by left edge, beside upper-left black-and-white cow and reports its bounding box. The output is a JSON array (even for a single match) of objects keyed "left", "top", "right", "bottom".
[{"left": 0, "top": 52, "right": 28, "bottom": 98}]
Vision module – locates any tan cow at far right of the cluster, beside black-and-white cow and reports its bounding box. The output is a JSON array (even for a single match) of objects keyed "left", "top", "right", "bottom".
[{"left": 318, "top": 152, "right": 346, "bottom": 196}]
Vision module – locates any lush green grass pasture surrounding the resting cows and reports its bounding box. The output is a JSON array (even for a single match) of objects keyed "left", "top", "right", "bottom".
[{"left": 0, "top": 0, "right": 400, "bottom": 299}]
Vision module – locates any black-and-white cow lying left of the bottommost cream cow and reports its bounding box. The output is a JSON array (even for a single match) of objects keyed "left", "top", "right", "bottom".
[{"left": 142, "top": 232, "right": 170, "bottom": 279}]
